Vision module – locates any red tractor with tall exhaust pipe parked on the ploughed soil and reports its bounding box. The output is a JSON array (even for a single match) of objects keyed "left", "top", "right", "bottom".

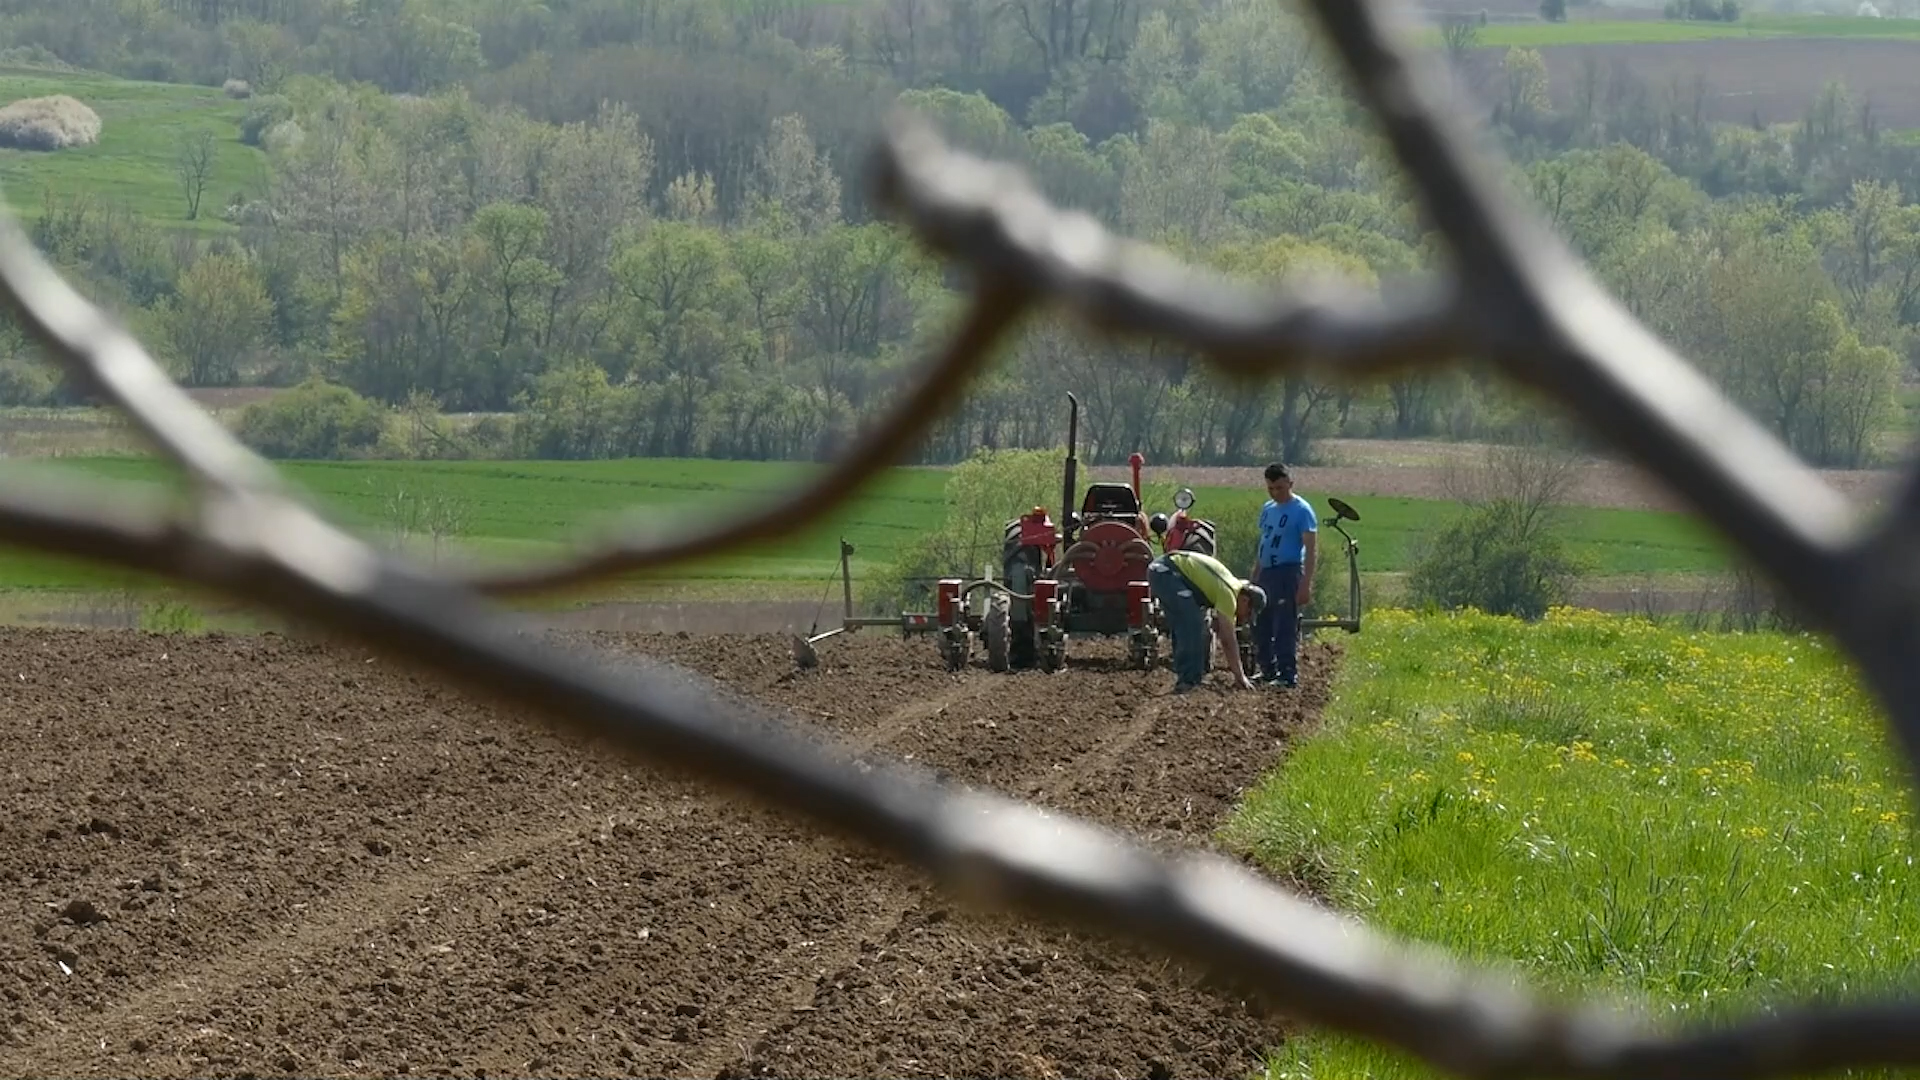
[{"left": 937, "top": 394, "right": 1213, "bottom": 671}]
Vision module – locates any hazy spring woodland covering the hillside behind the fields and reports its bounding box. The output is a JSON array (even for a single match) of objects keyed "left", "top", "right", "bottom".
[{"left": 0, "top": 0, "right": 1920, "bottom": 465}]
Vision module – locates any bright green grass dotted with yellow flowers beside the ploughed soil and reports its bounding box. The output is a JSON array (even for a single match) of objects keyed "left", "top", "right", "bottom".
[{"left": 1225, "top": 611, "right": 1920, "bottom": 1080}]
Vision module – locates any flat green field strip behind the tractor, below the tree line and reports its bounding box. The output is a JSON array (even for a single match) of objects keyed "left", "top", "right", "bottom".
[{"left": 0, "top": 457, "right": 1722, "bottom": 596}]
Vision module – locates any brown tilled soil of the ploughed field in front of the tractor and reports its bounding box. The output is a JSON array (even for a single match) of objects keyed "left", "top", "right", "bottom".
[{"left": 0, "top": 630, "right": 1331, "bottom": 1076}]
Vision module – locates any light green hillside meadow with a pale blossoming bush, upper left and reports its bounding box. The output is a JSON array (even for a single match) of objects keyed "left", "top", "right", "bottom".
[{"left": 0, "top": 69, "right": 267, "bottom": 231}]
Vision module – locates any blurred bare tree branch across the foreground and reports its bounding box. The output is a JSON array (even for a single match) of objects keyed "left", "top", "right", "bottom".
[{"left": 0, "top": 0, "right": 1920, "bottom": 1080}]
